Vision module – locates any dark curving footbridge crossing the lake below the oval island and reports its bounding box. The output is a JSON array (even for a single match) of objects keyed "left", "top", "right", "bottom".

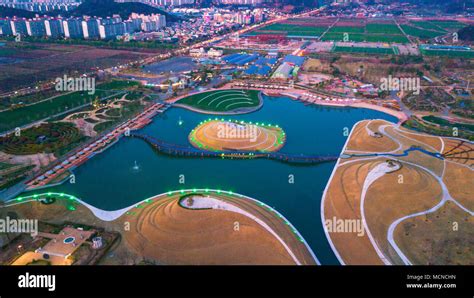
[{"left": 130, "top": 133, "right": 339, "bottom": 164}]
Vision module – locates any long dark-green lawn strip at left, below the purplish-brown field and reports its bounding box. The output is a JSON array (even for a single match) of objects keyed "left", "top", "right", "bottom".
[{"left": 0, "top": 81, "right": 138, "bottom": 131}]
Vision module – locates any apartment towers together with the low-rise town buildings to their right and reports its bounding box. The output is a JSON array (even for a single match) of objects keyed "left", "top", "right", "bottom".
[{"left": 0, "top": 8, "right": 268, "bottom": 42}]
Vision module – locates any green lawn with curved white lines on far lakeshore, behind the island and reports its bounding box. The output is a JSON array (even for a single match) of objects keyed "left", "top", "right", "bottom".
[{"left": 178, "top": 89, "right": 260, "bottom": 112}]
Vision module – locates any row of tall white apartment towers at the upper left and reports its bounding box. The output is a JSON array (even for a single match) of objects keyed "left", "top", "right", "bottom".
[{"left": 0, "top": 13, "right": 166, "bottom": 39}]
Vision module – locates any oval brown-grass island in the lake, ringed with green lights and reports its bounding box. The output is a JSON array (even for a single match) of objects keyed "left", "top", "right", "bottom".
[{"left": 189, "top": 120, "right": 285, "bottom": 152}]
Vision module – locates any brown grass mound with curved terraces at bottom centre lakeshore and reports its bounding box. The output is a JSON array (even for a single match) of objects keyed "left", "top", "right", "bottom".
[{"left": 123, "top": 197, "right": 300, "bottom": 264}]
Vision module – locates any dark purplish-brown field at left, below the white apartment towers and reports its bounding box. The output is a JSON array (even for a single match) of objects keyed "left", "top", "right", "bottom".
[{"left": 0, "top": 43, "right": 150, "bottom": 93}]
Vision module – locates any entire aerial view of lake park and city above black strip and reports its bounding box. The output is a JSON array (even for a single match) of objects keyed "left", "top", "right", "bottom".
[{"left": 0, "top": 0, "right": 474, "bottom": 266}]
